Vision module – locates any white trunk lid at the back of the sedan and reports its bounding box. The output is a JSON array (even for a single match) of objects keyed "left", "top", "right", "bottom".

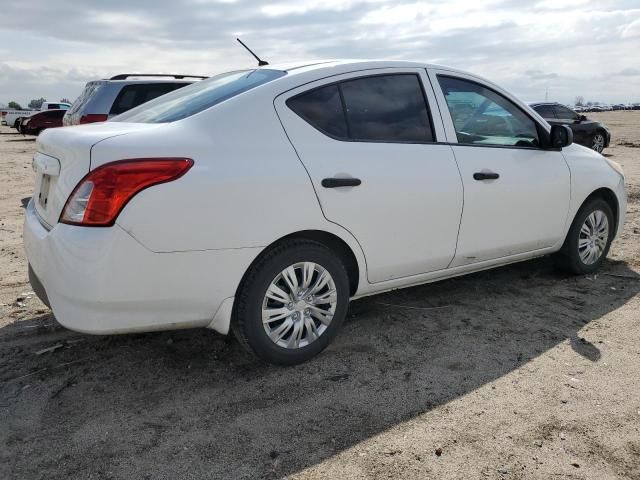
[{"left": 32, "top": 122, "right": 161, "bottom": 229}]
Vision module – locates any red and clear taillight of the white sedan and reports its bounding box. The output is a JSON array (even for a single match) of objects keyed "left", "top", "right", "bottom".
[{"left": 60, "top": 158, "right": 193, "bottom": 227}]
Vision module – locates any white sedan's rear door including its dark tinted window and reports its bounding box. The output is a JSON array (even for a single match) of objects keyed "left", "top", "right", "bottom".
[{"left": 275, "top": 68, "right": 462, "bottom": 283}]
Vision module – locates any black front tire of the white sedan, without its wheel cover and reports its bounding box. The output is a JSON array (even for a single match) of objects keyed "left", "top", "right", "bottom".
[{"left": 556, "top": 197, "right": 615, "bottom": 275}]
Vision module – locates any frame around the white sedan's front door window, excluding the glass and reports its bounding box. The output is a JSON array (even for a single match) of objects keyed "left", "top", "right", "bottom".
[{"left": 427, "top": 68, "right": 549, "bottom": 150}]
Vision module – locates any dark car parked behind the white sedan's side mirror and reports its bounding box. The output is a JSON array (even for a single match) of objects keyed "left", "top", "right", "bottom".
[{"left": 530, "top": 102, "right": 611, "bottom": 153}]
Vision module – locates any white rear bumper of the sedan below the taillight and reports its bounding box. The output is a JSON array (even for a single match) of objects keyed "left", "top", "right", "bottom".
[{"left": 24, "top": 202, "right": 260, "bottom": 334}]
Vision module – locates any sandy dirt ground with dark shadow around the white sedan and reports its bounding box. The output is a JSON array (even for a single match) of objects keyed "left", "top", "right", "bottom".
[{"left": 0, "top": 111, "right": 640, "bottom": 480}]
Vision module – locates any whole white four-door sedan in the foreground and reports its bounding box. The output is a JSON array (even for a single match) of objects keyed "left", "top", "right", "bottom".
[{"left": 24, "top": 61, "right": 626, "bottom": 364}]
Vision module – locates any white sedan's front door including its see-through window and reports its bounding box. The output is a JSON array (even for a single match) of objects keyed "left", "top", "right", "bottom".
[{"left": 429, "top": 70, "right": 571, "bottom": 267}]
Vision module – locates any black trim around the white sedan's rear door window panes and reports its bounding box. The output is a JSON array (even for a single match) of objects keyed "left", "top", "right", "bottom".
[{"left": 284, "top": 71, "right": 442, "bottom": 145}]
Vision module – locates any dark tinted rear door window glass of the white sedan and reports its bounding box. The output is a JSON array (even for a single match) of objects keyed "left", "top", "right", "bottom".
[{"left": 287, "top": 74, "right": 434, "bottom": 143}]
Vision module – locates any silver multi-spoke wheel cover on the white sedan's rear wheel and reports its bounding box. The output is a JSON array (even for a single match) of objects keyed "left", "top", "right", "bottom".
[{"left": 262, "top": 262, "right": 338, "bottom": 349}]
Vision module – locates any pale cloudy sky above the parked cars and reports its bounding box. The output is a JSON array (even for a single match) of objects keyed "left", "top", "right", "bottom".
[{"left": 0, "top": 0, "right": 640, "bottom": 106}]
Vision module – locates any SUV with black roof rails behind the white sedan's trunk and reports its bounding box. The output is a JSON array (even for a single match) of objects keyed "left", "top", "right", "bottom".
[{"left": 63, "top": 73, "right": 207, "bottom": 125}]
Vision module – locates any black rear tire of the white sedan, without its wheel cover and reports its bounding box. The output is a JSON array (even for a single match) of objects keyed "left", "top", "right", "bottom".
[{"left": 231, "top": 239, "right": 349, "bottom": 365}]
